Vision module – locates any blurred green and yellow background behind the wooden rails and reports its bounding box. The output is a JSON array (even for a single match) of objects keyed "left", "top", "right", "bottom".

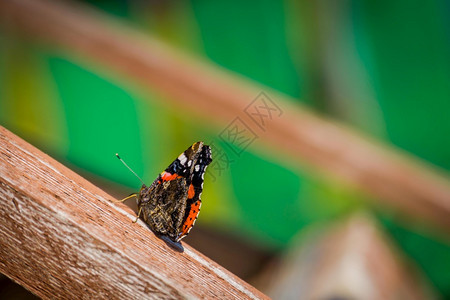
[{"left": 0, "top": 0, "right": 450, "bottom": 298}]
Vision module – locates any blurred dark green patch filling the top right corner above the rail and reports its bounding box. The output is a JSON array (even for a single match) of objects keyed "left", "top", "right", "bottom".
[{"left": 354, "top": 0, "right": 450, "bottom": 170}]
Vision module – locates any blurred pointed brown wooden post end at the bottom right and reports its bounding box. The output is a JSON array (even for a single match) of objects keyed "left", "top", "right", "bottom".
[{"left": 265, "top": 214, "right": 436, "bottom": 300}]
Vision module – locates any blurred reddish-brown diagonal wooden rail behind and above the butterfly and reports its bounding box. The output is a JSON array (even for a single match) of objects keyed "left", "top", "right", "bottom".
[{"left": 0, "top": 0, "right": 450, "bottom": 233}]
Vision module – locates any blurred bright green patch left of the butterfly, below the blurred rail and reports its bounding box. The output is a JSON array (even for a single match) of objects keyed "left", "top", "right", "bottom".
[{"left": 48, "top": 57, "right": 143, "bottom": 184}]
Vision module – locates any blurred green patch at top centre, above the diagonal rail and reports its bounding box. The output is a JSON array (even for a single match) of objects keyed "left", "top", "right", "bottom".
[{"left": 192, "top": 0, "right": 300, "bottom": 98}]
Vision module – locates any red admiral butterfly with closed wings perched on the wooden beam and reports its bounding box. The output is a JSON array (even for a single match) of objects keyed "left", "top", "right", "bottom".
[{"left": 116, "top": 142, "right": 212, "bottom": 247}]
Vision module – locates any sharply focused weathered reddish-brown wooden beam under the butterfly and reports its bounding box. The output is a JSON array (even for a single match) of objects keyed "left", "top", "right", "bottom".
[{"left": 0, "top": 127, "right": 266, "bottom": 299}]
